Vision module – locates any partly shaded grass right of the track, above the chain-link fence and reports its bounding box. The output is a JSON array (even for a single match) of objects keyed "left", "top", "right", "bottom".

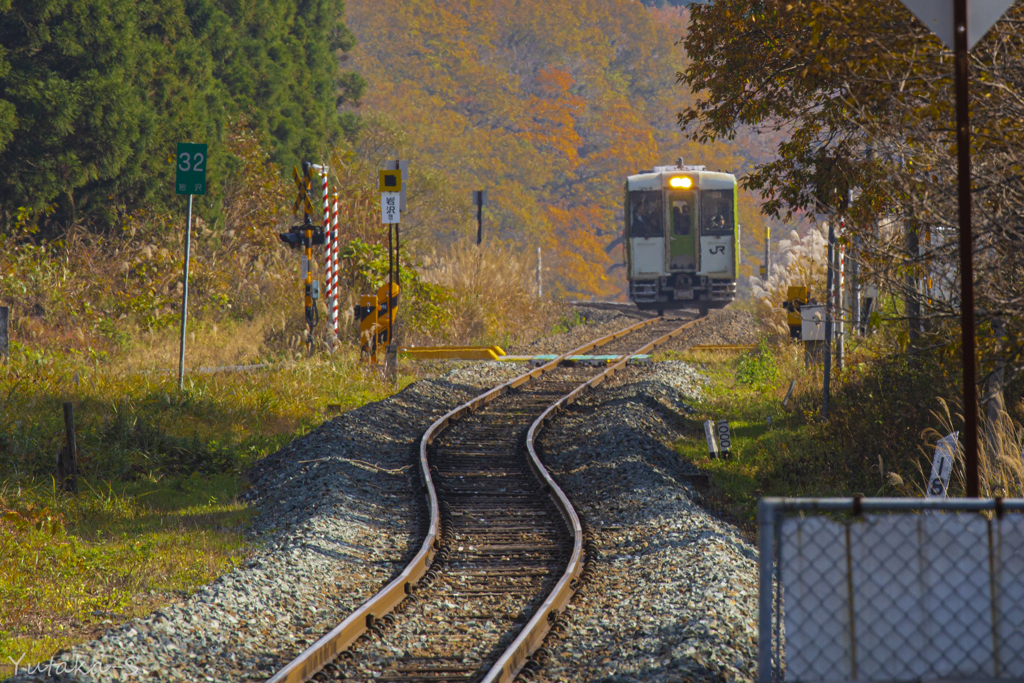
[{"left": 660, "top": 341, "right": 961, "bottom": 530}]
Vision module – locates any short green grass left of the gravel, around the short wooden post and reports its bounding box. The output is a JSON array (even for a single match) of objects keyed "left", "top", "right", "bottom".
[{"left": 0, "top": 344, "right": 415, "bottom": 677}]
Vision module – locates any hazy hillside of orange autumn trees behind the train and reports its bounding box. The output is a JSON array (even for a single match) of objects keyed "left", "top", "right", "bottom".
[{"left": 345, "top": 0, "right": 760, "bottom": 297}]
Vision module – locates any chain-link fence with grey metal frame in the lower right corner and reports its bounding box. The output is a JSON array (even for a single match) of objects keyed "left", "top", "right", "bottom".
[{"left": 758, "top": 498, "right": 1024, "bottom": 683}]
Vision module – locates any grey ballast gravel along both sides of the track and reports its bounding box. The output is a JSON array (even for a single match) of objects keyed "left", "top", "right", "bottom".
[{"left": 6, "top": 321, "right": 757, "bottom": 683}]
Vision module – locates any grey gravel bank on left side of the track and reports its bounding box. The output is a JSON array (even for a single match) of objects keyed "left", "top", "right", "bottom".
[{"left": 6, "top": 364, "right": 520, "bottom": 682}]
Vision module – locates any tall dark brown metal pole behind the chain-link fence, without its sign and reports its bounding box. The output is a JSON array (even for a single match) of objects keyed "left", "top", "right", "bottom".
[{"left": 953, "top": 0, "right": 980, "bottom": 498}]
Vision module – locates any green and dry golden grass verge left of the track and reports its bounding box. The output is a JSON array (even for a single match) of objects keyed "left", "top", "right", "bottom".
[{"left": 0, "top": 120, "right": 559, "bottom": 673}]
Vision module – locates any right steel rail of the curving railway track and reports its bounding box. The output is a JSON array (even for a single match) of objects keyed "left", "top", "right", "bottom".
[{"left": 481, "top": 317, "right": 700, "bottom": 683}]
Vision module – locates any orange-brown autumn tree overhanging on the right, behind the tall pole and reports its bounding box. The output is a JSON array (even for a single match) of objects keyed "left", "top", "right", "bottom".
[{"left": 680, "top": 0, "right": 1024, "bottom": 389}]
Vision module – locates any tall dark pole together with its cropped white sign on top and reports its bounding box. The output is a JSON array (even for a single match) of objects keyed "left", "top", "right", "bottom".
[{"left": 902, "top": 0, "right": 1014, "bottom": 498}]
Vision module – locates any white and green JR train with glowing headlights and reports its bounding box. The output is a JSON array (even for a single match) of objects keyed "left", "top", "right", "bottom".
[{"left": 625, "top": 167, "right": 739, "bottom": 310}]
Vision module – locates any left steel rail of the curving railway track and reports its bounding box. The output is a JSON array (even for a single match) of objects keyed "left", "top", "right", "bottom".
[{"left": 267, "top": 317, "right": 663, "bottom": 683}]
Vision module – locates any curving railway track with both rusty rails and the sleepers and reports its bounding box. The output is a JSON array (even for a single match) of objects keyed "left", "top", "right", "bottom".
[{"left": 269, "top": 317, "right": 695, "bottom": 683}]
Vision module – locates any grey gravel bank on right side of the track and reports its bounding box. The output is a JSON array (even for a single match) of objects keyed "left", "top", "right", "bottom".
[{"left": 536, "top": 362, "right": 757, "bottom": 683}]
